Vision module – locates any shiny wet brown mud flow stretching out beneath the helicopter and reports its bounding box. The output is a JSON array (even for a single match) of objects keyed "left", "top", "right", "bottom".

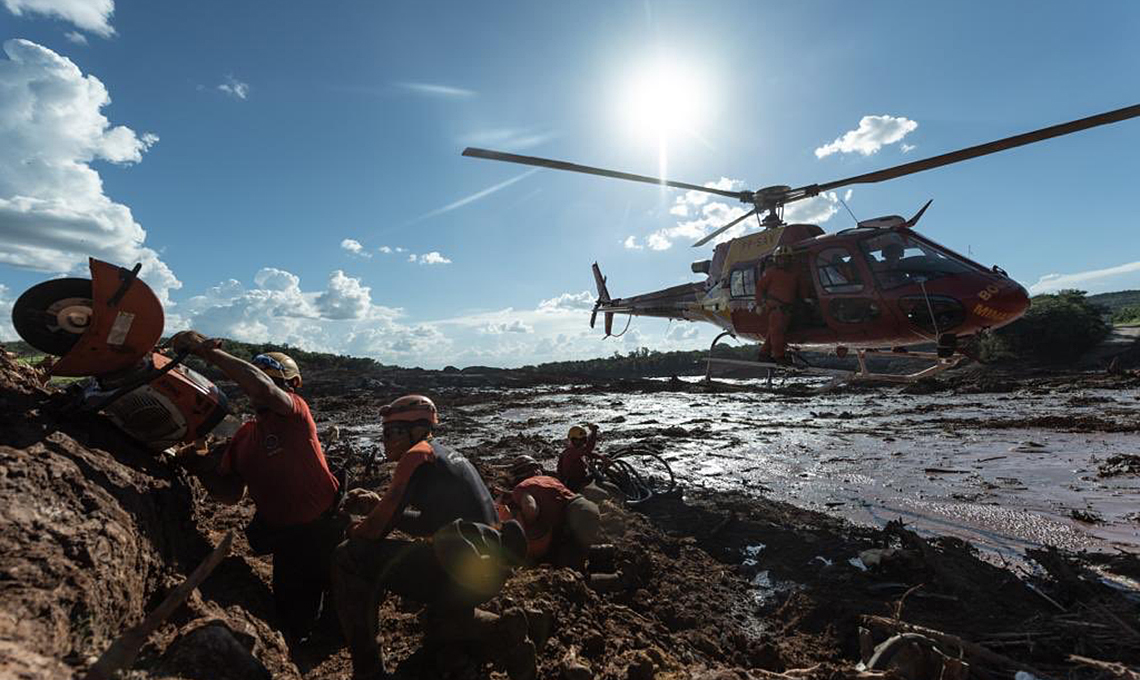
[{"left": 345, "top": 378, "right": 1140, "bottom": 561}]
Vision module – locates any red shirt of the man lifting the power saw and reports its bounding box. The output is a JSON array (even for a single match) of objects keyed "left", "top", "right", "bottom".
[{"left": 220, "top": 395, "right": 337, "bottom": 527}]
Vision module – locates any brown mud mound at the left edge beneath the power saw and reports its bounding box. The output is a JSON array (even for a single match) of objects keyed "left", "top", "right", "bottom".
[{"left": 0, "top": 355, "right": 298, "bottom": 678}]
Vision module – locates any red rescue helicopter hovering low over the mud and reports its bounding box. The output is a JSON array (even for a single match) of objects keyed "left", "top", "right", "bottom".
[{"left": 463, "top": 105, "right": 1140, "bottom": 382}]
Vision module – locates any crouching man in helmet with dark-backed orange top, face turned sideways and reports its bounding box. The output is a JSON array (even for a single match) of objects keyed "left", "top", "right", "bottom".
[{"left": 333, "top": 395, "right": 526, "bottom": 680}]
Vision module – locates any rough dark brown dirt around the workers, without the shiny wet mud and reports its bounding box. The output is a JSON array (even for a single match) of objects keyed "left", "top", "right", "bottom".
[{"left": 0, "top": 356, "right": 1140, "bottom": 680}]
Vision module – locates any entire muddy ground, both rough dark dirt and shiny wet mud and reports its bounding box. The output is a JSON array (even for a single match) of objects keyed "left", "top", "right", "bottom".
[{"left": 0, "top": 357, "right": 1140, "bottom": 679}]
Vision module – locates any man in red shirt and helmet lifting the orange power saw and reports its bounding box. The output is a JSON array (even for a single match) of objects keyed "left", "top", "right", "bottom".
[{"left": 171, "top": 331, "right": 348, "bottom": 642}]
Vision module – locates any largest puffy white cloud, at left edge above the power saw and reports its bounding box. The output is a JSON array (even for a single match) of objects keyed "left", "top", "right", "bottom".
[{"left": 0, "top": 40, "right": 181, "bottom": 302}]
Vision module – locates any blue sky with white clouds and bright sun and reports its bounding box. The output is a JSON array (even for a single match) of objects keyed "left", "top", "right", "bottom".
[{"left": 0, "top": 0, "right": 1140, "bottom": 367}]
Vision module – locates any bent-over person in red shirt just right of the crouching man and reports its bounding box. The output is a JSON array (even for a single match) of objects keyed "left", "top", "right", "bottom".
[{"left": 503, "top": 455, "right": 600, "bottom": 572}]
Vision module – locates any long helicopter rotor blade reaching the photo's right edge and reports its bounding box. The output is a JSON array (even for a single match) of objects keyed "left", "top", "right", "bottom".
[{"left": 802, "top": 104, "right": 1140, "bottom": 196}]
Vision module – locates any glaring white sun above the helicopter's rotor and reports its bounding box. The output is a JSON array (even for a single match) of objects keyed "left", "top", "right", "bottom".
[{"left": 619, "top": 58, "right": 708, "bottom": 175}]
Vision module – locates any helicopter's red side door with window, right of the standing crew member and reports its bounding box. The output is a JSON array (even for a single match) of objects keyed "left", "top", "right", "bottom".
[{"left": 812, "top": 245, "right": 894, "bottom": 342}]
